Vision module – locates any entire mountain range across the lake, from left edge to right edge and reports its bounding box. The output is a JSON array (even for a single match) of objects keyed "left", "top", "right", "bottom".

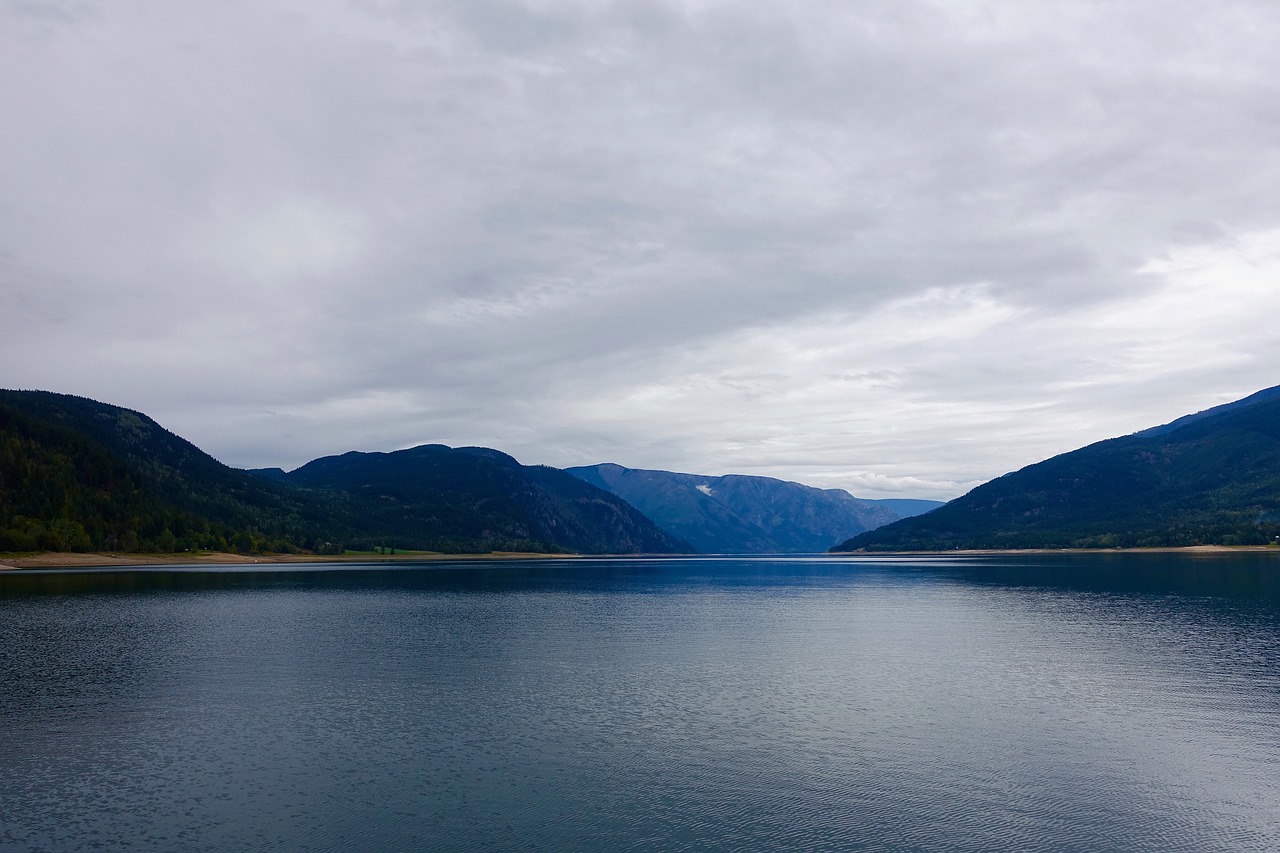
[{"left": 0, "top": 388, "right": 1280, "bottom": 555}]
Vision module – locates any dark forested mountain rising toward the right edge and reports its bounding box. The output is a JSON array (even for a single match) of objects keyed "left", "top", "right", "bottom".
[{"left": 835, "top": 387, "right": 1280, "bottom": 551}]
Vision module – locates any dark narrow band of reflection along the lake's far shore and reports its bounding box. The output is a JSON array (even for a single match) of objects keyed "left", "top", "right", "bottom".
[{"left": 0, "top": 551, "right": 1280, "bottom": 603}]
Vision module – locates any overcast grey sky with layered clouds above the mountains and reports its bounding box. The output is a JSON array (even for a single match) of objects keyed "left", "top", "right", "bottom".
[{"left": 0, "top": 0, "right": 1280, "bottom": 498}]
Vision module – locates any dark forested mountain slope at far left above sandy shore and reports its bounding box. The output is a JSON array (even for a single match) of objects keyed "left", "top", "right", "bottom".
[{"left": 0, "top": 391, "right": 332, "bottom": 551}]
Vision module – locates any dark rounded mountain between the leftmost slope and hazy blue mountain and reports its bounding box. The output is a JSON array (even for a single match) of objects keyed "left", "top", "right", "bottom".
[{"left": 266, "top": 444, "right": 690, "bottom": 553}]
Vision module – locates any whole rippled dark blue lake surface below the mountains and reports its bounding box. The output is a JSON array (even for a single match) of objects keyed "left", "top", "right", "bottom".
[{"left": 0, "top": 555, "right": 1280, "bottom": 853}]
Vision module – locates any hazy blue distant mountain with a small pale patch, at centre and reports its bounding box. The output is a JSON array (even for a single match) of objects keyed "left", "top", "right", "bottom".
[{"left": 564, "top": 464, "right": 901, "bottom": 553}]
